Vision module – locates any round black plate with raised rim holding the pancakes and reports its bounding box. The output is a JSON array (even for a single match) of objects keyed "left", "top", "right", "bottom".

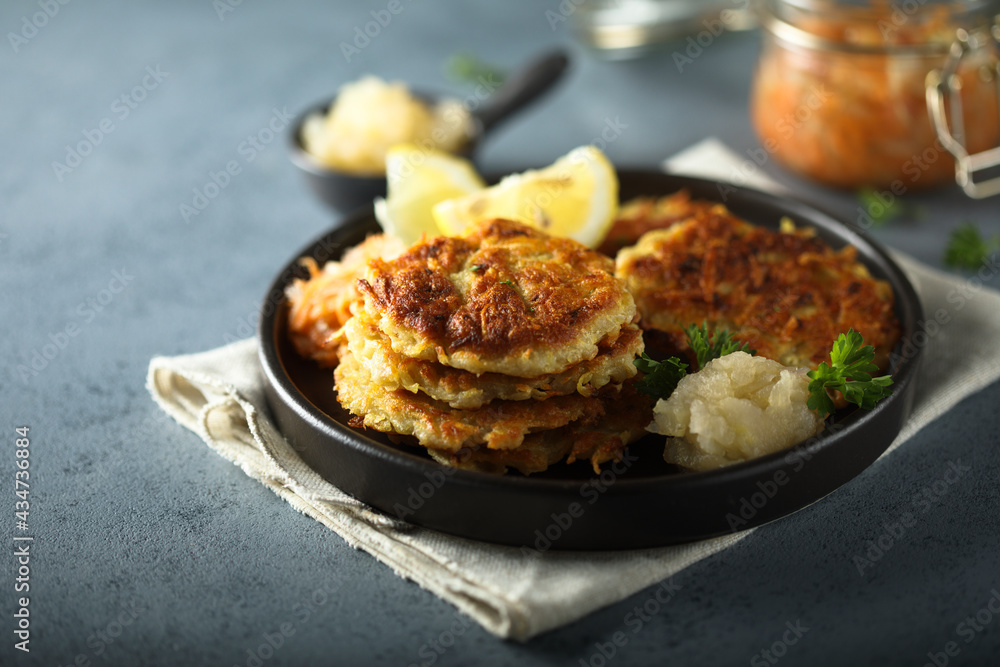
[{"left": 259, "top": 170, "right": 921, "bottom": 551}]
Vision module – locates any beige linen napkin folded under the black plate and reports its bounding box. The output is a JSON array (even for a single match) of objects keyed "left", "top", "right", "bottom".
[{"left": 148, "top": 141, "right": 1000, "bottom": 640}]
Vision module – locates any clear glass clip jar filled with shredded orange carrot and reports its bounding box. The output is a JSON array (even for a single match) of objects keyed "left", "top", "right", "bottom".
[{"left": 750, "top": 0, "right": 1000, "bottom": 194}]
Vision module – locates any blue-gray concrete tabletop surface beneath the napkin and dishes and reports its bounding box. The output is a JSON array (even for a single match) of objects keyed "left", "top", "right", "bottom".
[{"left": 0, "top": 0, "right": 1000, "bottom": 666}]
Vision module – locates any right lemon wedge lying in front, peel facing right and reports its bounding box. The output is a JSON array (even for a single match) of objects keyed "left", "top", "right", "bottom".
[{"left": 433, "top": 146, "right": 618, "bottom": 248}]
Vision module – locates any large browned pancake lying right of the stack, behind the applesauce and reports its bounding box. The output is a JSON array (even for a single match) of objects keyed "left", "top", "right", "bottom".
[{"left": 616, "top": 205, "right": 900, "bottom": 367}]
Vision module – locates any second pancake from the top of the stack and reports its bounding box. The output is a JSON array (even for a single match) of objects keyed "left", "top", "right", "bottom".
[{"left": 344, "top": 312, "right": 643, "bottom": 409}]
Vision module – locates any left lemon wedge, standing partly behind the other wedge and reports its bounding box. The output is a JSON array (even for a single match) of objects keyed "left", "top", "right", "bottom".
[{"left": 375, "top": 144, "right": 486, "bottom": 245}]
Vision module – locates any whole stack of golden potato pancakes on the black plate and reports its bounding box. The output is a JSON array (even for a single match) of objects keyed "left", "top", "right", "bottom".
[{"left": 334, "top": 220, "right": 649, "bottom": 473}]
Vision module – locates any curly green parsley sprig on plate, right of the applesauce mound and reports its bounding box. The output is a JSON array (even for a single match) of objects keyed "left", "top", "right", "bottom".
[{"left": 806, "top": 329, "right": 892, "bottom": 417}]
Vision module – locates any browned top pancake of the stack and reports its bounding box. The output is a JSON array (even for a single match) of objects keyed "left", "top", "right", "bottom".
[{"left": 358, "top": 220, "right": 635, "bottom": 377}]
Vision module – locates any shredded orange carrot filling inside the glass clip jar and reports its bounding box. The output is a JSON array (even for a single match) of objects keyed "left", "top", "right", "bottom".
[{"left": 751, "top": 3, "right": 1000, "bottom": 189}]
